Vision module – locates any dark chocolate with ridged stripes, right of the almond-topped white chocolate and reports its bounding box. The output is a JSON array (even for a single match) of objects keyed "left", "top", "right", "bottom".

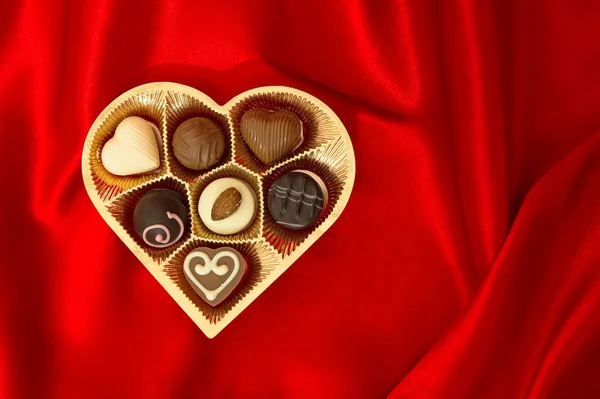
[{"left": 267, "top": 170, "right": 327, "bottom": 230}]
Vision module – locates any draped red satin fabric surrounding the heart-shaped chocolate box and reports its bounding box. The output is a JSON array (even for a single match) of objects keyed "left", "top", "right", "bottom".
[{"left": 0, "top": 0, "right": 600, "bottom": 399}]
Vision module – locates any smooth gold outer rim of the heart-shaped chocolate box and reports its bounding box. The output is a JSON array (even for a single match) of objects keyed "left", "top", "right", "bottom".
[{"left": 81, "top": 82, "right": 356, "bottom": 338}]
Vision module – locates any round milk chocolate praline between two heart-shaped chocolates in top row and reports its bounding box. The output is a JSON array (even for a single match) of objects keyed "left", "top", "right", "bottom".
[{"left": 173, "top": 117, "right": 225, "bottom": 170}]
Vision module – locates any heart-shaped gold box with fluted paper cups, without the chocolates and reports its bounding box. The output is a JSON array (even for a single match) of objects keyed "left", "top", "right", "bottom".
[{"left": 81, "top": 82, "right": 355, "bottom": 338}]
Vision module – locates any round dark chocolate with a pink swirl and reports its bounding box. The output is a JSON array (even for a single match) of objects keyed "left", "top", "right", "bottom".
[{"left": 133, "top": 189, "right": 188, "bottom": 248}]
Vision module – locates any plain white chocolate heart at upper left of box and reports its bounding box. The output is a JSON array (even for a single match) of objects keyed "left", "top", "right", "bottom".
[{"left": 101, "top": 116, "right": 160, "bottom": 176}]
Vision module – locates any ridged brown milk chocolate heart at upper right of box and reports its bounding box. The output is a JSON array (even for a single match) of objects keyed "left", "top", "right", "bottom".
[{"left": 240, "top": 108, "right": 303, "bottom": 165}]
